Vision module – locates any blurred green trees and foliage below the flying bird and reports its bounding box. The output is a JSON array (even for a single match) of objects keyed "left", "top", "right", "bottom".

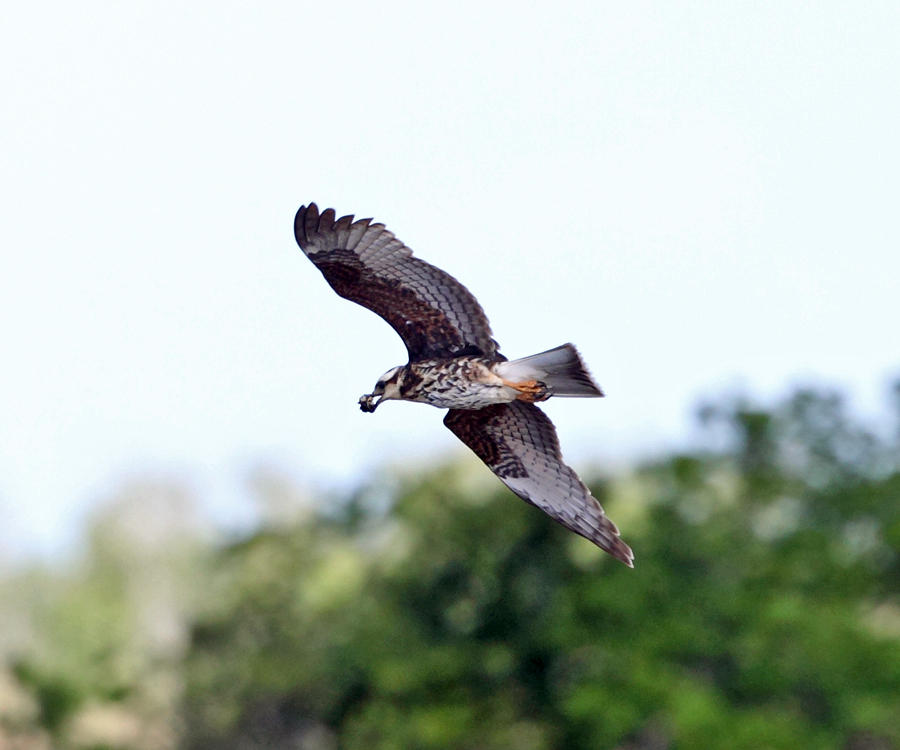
[{"left": 0, "top": 386, "right": 900, "bottom": 750}]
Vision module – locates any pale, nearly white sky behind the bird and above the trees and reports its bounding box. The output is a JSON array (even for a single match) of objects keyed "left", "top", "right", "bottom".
[{"left": 0, "top": 2, "right": 900, "bottom": 557}]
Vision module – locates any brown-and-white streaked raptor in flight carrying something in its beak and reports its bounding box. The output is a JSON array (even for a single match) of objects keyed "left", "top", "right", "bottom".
[{"left": 294, "top": 203, "right": 634, "bottom": 567}]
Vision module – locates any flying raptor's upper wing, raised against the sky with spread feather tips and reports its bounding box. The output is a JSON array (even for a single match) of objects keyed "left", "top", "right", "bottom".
[{"left": 294, "top": 203, "right": 498, "bottom": 362}]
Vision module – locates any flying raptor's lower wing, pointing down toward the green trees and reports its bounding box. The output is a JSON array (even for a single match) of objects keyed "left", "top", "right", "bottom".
[{"left": 444, "top": 401, "right": 634, "bottom": 567}]
